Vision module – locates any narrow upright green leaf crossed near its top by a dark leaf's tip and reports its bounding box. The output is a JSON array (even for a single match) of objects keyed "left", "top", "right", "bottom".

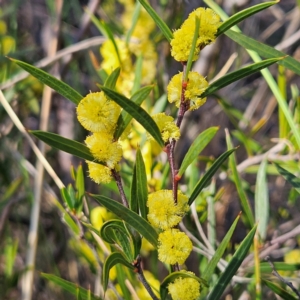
[{"left": 226, "top": 131, "right": 254, "bottom": 227}]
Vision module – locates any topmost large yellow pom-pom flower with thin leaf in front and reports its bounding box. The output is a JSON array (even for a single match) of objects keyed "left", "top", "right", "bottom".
[{"left": 171, "top": 7, "right": 221, "bottom": 61}]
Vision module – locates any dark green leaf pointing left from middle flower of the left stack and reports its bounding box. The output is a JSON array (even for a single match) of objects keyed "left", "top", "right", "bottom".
[{"left": 29, "top": 130, "right": 95, "bottom": 161}]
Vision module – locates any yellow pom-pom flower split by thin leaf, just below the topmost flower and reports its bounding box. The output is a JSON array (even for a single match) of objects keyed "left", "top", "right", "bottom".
[{"left": 167, "top": 72, "right": 208, "bottom": 110}]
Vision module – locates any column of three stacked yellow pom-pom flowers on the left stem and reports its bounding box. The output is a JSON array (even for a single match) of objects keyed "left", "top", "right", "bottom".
[{"left": 77, "top": 92, "right": 123, "bottom": 184}]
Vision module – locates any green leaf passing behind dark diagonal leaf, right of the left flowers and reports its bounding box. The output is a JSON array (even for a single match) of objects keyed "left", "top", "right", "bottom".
[{"left": 114, "top": 86, "right": 153, "bottom": 140}]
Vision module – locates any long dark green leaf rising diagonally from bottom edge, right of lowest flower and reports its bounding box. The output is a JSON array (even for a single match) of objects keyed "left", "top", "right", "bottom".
[{"left": 207, "top": 225, "right": 257, "bottom": 300}]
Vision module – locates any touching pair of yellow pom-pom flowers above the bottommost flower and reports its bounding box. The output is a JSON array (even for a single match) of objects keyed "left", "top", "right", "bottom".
[{"left": 147, "top": 190, "right": 193, "bottom": 265}]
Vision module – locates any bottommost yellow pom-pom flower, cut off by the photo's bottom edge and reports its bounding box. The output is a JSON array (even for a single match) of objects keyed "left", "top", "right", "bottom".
[{"left": 168, "top": 272, "right": 200, "bottom": 300}]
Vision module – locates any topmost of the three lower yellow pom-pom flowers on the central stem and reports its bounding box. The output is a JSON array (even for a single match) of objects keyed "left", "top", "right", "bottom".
[{"left": 147, "top": 190, "right": 189, "bottom": 230}]
